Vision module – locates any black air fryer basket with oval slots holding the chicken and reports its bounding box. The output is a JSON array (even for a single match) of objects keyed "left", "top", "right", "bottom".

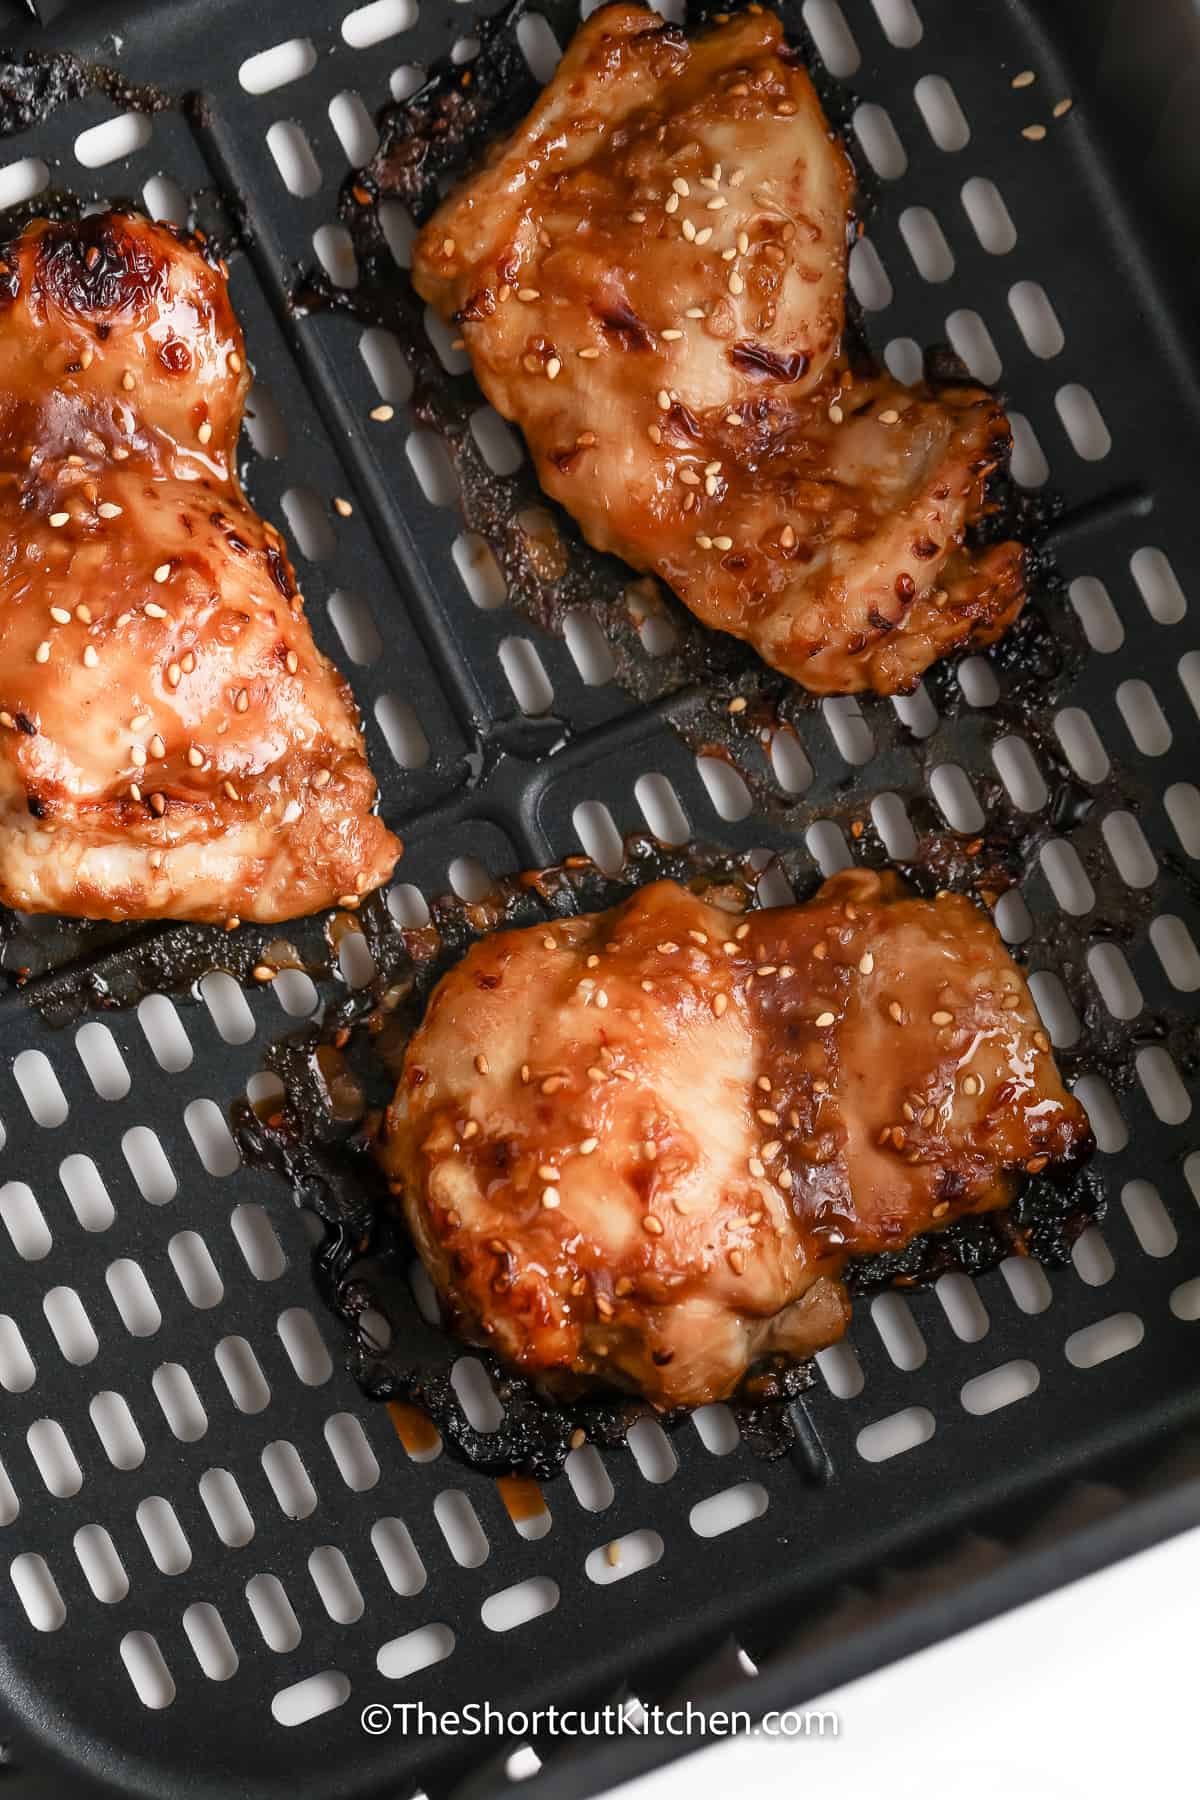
[{"left": 0, "top": 0, "right": 1200, "bottom": 1800}]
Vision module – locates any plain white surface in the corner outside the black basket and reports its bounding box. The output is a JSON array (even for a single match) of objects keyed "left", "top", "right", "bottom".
[{"left": 617, "top": 1528, "right": 1200, "bottom": 1800}]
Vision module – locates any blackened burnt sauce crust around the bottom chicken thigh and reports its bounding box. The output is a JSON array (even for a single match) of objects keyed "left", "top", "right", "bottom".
[{"left": 234, "top": 837, "right": 1105, "bottom": 1480}]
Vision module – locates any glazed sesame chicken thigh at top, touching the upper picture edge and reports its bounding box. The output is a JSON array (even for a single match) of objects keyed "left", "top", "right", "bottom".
[{"left": 412, "top": 4, "right": 1024, "bottom": 693}]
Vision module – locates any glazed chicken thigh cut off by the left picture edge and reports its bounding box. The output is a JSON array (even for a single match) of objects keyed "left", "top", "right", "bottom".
[{"left": 0, "top": 212, "right": 399, "bottom": 922}]
